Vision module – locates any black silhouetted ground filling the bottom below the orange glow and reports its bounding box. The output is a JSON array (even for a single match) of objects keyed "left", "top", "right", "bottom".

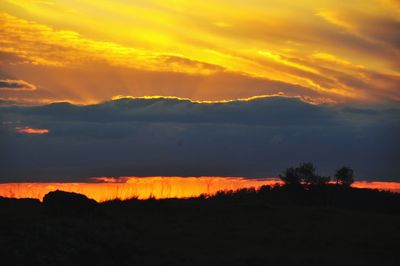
[{"left": 0, "top": 187, "right": 400, "bottom": 266}]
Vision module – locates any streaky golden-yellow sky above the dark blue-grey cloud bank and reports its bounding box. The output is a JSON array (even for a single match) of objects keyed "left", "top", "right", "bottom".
[{"left": 0, "top": 0, "right": 400, "bottom": 104}]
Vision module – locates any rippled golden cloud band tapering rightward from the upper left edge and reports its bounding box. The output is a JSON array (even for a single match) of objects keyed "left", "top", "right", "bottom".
[{"left": 0, "top": 13, "right": 225, "bottom": 74}]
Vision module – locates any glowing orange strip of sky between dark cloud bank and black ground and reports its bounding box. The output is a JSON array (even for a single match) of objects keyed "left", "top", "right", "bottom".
[{"left": 0, "top": 176, "right": 400, "bottom": 202}]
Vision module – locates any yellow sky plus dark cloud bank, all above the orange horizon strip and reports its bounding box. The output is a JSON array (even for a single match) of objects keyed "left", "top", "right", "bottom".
[{"left": 0, "top": 0, "right": 400, "bottom": 182}]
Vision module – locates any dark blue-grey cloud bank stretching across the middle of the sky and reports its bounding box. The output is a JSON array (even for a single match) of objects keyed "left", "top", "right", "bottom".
[{"left": 0, "top": 97, "right": 400, "bottom": 182}]
